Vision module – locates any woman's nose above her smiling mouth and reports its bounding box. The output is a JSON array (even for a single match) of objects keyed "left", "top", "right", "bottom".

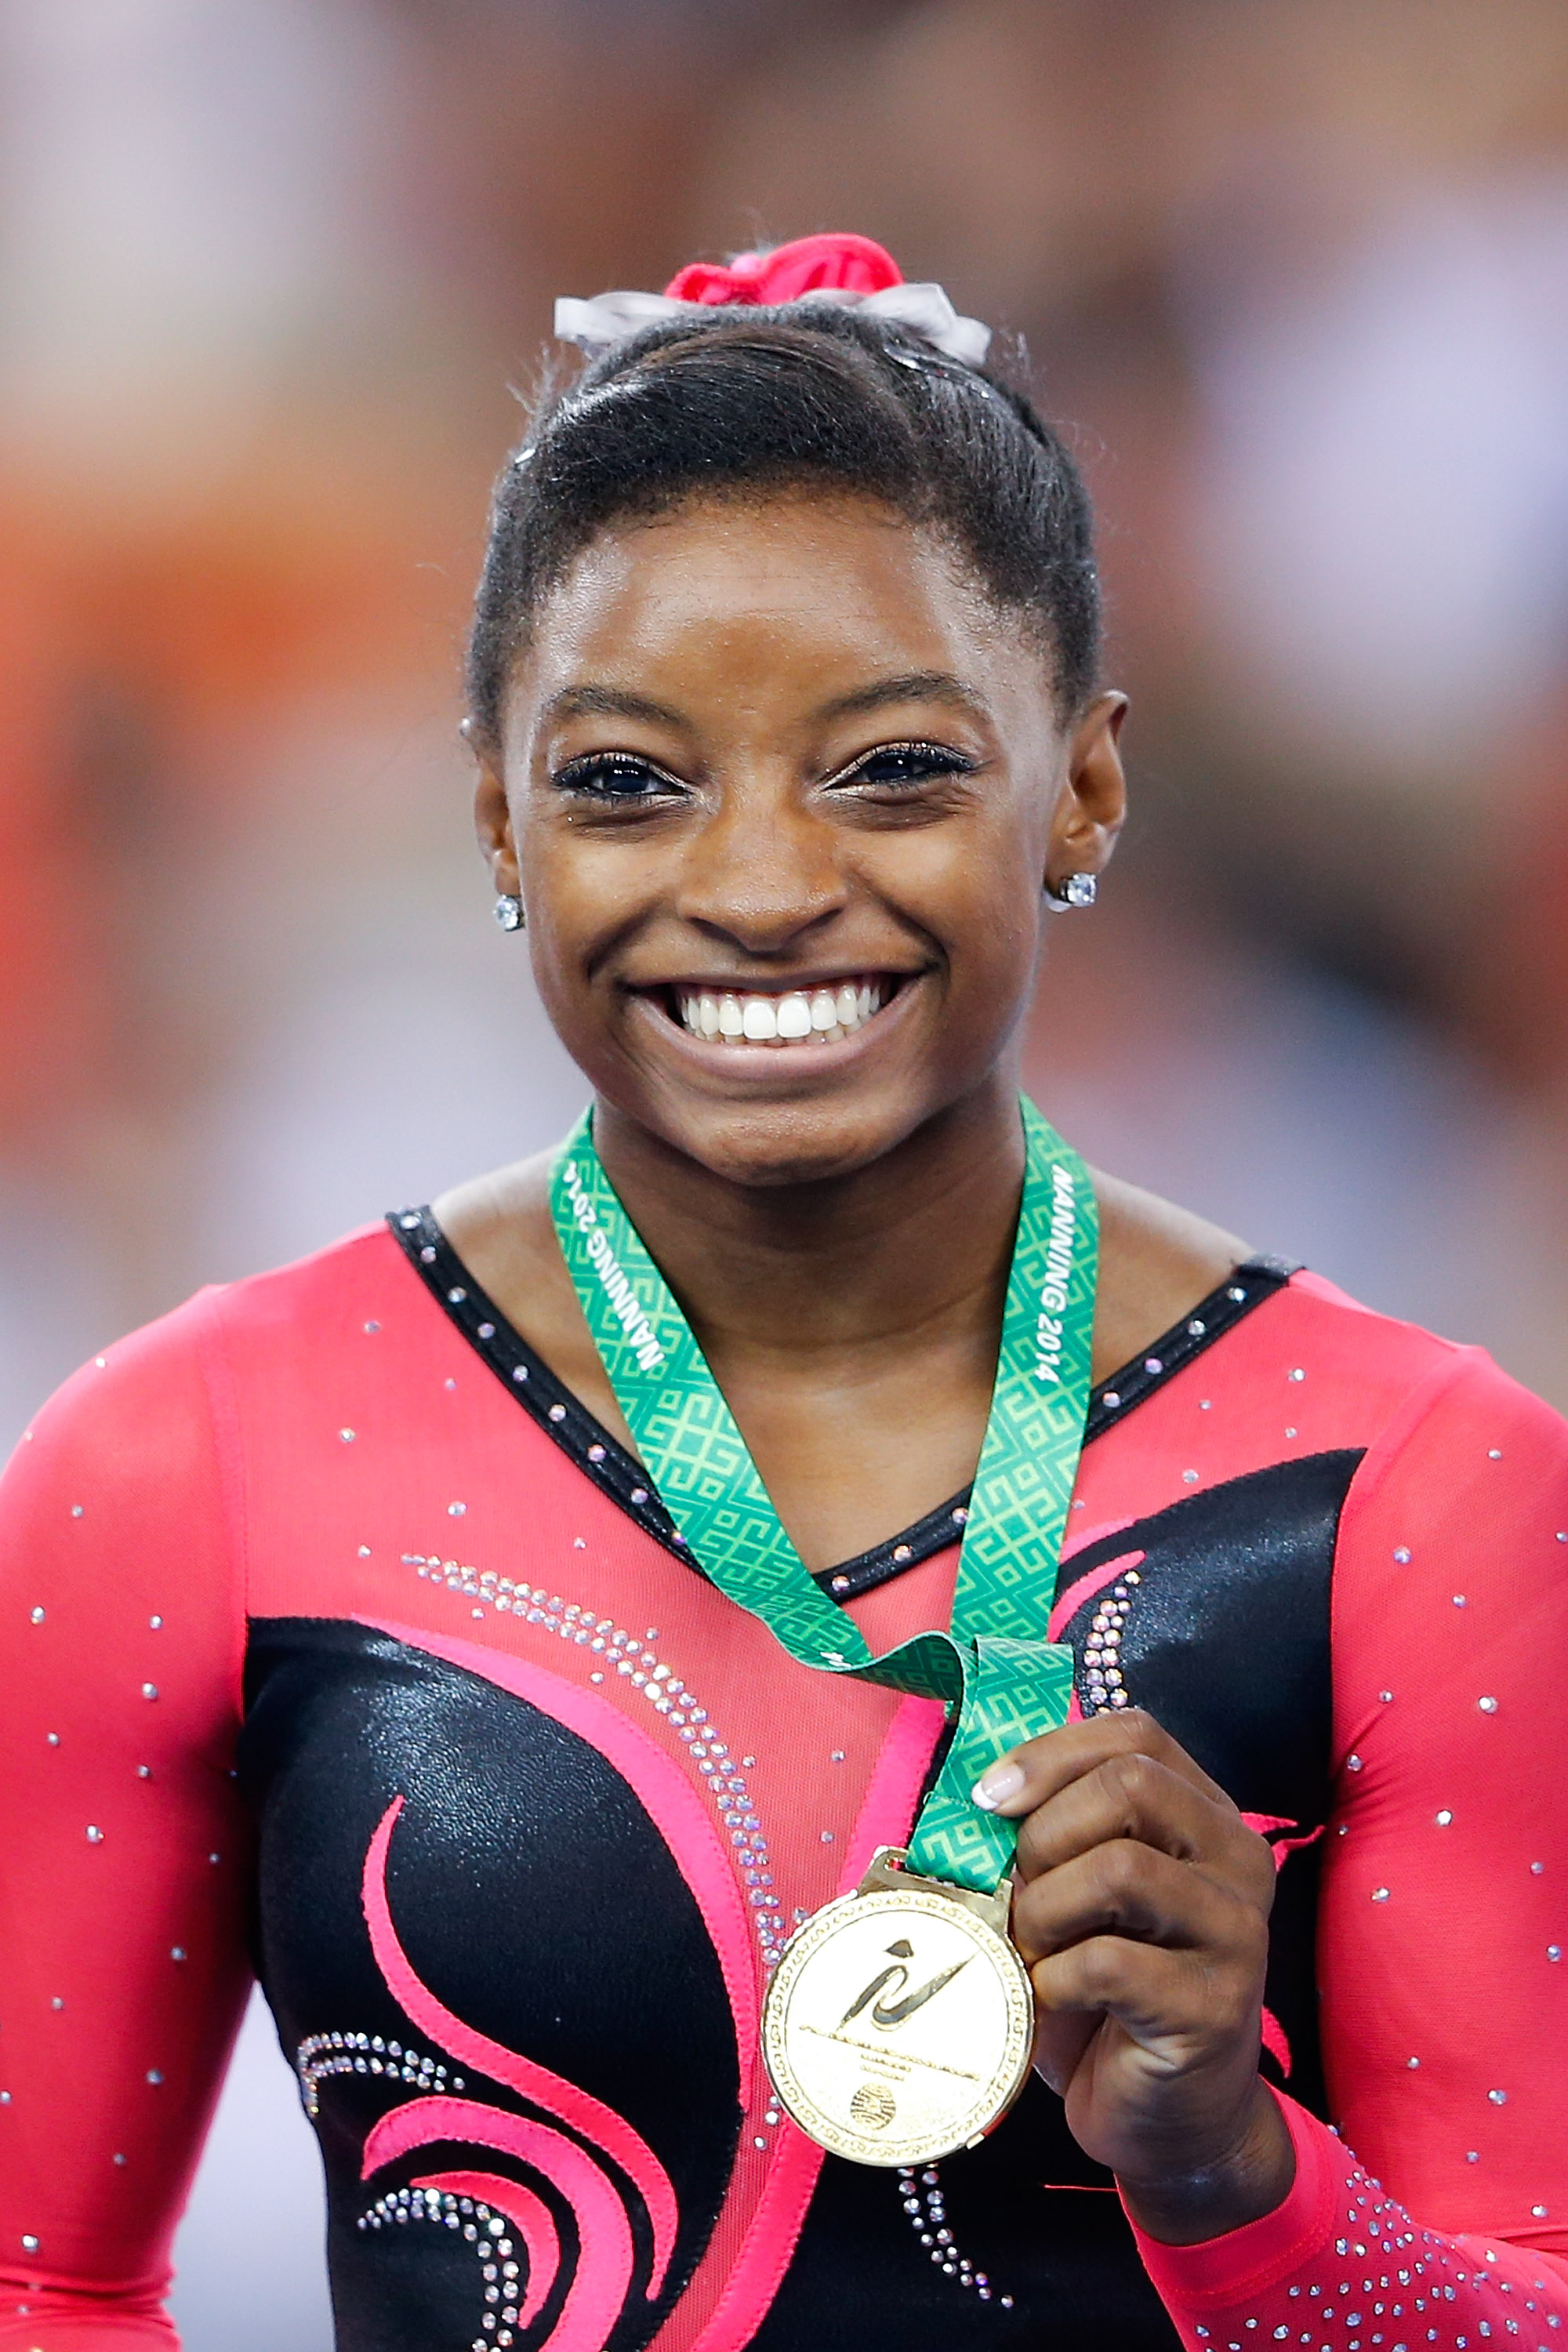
[{"left": 677, "top": 790, "right": 848, "bottom": 955}]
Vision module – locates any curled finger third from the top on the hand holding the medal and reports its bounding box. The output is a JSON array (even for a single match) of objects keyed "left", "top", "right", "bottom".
[{"left": 1013, "top": 1839, "right": 1267, "bottom": 1966}]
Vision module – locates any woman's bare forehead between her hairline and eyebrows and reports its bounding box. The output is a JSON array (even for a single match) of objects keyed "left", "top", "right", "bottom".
[{"left": 513, "top": 489, "right": 1048, "bottom": 720}]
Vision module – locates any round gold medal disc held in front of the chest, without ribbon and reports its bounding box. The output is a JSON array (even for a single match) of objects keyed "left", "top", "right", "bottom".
[{"left": 762, "top": 1846, "right": 1034, "bottom": 2166}]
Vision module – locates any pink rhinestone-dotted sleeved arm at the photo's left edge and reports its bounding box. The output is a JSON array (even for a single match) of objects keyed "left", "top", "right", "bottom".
[{"left": 0, "top": 1308, "right": 247, "bottom": 2340}]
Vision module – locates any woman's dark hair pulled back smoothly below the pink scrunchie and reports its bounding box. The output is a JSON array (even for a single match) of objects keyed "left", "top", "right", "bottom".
[{"left": 468, "top": 303, "right": 1100, "bottom": 743}]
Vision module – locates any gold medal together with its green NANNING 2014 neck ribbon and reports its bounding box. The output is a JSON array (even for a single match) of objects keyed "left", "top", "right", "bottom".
[{"left": 550, "top": 1101, "right": 1098, "bottom": 2166}]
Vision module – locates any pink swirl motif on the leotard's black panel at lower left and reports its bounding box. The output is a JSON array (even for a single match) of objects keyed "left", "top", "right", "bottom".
[{"left": 360, "top": 1797, "right": 680, "bottom": 2352}]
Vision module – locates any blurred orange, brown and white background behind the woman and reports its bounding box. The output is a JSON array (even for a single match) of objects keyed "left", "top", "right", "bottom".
[{"left": 0, "top": 0, "right": 1568, "bottom": 2352}]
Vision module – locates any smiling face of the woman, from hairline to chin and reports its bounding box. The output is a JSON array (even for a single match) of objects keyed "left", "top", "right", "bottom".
[{"left": 477, "top": 492, "right": 1121, "bottom": 1185}]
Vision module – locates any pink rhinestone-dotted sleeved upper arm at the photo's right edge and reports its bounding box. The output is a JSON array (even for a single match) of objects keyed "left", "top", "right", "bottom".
[{"left": 1319, "top": 1357, "right": 1568, "bottom": 2251}]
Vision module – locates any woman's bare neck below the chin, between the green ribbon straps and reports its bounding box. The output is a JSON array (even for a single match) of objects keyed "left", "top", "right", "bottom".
[{"left": 595, "top": 1073, "right": 1025, "bottom": 1364}]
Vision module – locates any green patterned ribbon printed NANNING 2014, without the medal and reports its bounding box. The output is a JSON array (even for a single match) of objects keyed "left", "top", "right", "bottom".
[{"left": 550, "top": 1098, "right": 1098, "bottom": 1893}]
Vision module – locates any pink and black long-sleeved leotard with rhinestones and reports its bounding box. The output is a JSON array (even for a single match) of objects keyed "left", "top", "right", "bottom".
[{"left": 0, "top": 1211, "right": 1568, "bottom": 2352}]
